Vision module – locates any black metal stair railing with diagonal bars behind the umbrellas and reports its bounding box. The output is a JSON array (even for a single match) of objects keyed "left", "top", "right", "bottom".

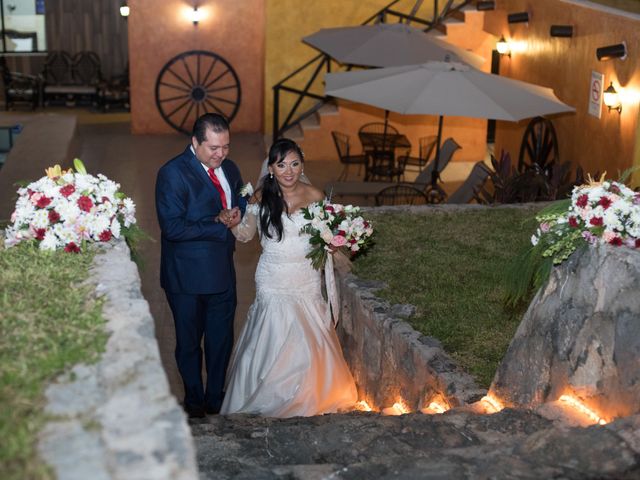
[{"left": 272, "top": 0, "right": 474, "bottom": 140}]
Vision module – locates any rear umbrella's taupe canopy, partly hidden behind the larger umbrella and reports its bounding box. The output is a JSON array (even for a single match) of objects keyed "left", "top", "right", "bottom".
[{"left": 302, "top": 23, "right": 484, "bottom": 68}]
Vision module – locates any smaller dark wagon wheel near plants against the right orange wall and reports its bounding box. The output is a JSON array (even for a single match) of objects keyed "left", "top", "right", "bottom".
[{"left": 518, "top": 117, "right": 558, "bottom": 173}]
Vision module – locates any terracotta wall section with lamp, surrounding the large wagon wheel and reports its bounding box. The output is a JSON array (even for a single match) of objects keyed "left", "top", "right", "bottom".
[{"left": 128, "top": 0, "right": 265, "bottom": 134}]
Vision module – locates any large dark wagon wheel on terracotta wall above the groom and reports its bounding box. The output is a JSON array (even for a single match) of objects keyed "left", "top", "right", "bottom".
[{"left": 156, "top": 50, "right": 241, "bottom": 135}]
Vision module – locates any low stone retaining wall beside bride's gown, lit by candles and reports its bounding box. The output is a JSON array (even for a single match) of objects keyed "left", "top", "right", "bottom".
[{"left": 337, "top": 258, "right": 486, "bottom": 411}]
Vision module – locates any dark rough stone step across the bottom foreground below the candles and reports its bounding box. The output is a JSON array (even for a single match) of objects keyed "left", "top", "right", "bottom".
[{"left": 191, "top": 409, "right": 640, "bottom": 480}]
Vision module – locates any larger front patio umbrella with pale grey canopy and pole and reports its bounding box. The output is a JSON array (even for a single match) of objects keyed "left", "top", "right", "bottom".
[{"left": 325, "top": 62, "right": 575, "bottom": 187}]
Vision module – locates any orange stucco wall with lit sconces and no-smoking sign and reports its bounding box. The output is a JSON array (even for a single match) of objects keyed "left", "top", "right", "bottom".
[{"left": 485, "top": 0, "right": 640, "bottom": 185}]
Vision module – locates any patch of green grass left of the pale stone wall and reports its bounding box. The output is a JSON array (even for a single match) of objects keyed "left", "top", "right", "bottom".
[{"left": 0, "top": 245, "right": 107, "bottom": 480}]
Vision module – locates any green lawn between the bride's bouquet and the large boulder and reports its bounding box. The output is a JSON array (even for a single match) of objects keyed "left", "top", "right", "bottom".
[{"left": 354, "top": 208, "right": 535, "bottom": 387}]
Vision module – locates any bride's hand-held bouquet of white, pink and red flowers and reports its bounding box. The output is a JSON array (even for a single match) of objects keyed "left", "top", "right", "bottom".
[{"left": 300, "top": 202, "right": 373, "bottom": 270}]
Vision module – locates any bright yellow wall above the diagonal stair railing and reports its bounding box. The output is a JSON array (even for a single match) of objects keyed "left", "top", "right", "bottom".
[{"left": 264, "top": 0, "right": 443, "bottom": 137}]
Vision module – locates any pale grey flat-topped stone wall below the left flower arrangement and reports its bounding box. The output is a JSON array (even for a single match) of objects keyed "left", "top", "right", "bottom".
[{"left": 39, "top": 241, "right": 198, "bottom": 480}]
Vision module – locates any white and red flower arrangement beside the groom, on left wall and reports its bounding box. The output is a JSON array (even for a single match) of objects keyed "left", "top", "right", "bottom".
[{"left": 5, "top": 158, "right": 136, "bottom": 253}]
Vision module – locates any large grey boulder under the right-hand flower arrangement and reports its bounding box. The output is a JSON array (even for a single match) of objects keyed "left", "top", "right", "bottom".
[{"left": 490, "top": 246, "right": 640, "bottom": 420}]
